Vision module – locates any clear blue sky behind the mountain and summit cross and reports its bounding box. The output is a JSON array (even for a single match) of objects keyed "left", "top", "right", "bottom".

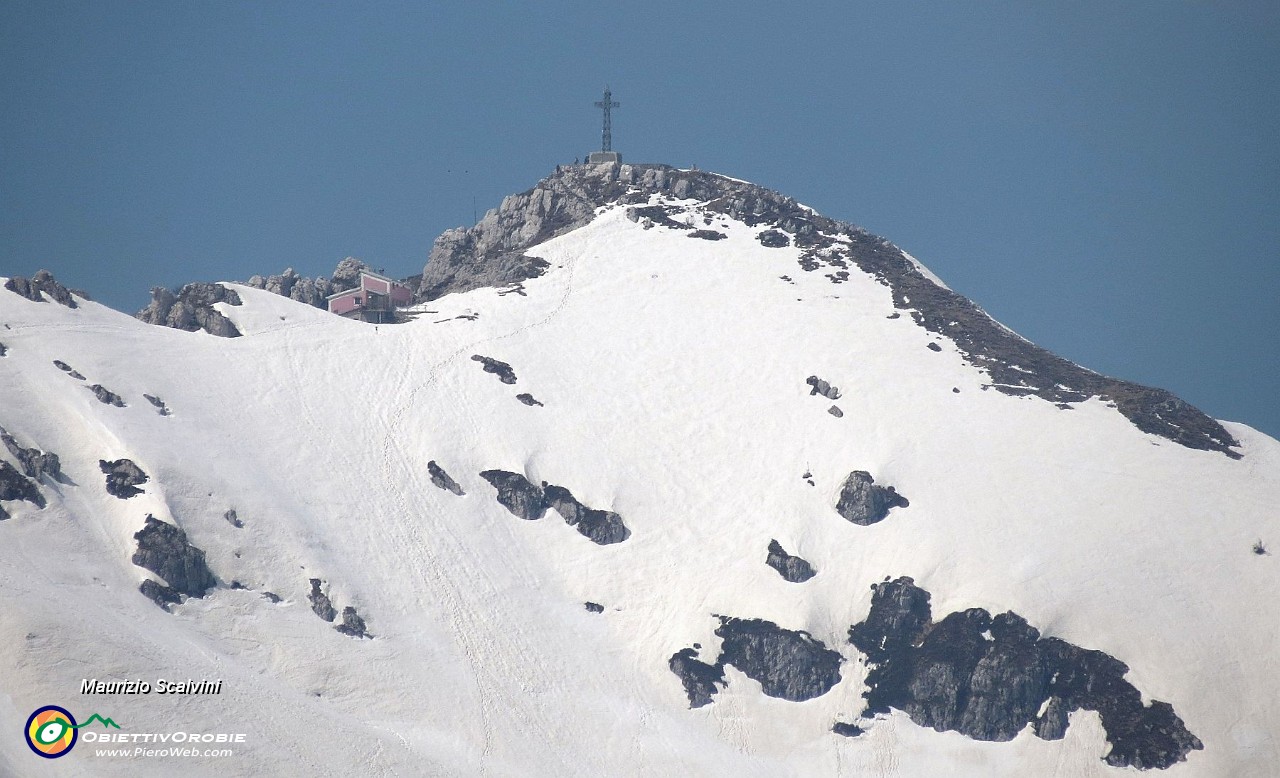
[{"left": 0, "top": 0, "right": 1280, "bottom": 436}]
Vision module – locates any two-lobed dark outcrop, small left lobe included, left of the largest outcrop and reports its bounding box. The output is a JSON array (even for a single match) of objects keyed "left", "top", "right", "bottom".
[{"left": 668, "top": 615, "right": 844, "bottom": 708}]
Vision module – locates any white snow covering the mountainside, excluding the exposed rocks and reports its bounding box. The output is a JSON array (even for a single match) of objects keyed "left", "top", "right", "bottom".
[{"left": 0, "top": 191, "right": 1280, "bottom": 777}]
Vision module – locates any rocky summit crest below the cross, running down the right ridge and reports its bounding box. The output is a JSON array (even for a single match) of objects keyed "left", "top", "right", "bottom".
[{"left": 419, "top": 164, "right": 1240, "bottom": 458}]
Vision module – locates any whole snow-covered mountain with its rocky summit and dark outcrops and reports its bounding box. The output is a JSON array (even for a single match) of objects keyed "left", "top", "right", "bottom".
[{"left": 0, "top": 161, "right": 1280, "bottom": 775}]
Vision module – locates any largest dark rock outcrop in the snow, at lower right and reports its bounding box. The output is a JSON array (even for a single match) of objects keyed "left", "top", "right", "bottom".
[{"left": 849, "top": 577, "right": 1203, "bottom": 769}]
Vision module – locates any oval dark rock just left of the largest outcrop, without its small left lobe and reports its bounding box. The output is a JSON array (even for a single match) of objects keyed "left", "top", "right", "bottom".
[{"left": 716, "top": 615, "right": 842, "bottom": 703}]
